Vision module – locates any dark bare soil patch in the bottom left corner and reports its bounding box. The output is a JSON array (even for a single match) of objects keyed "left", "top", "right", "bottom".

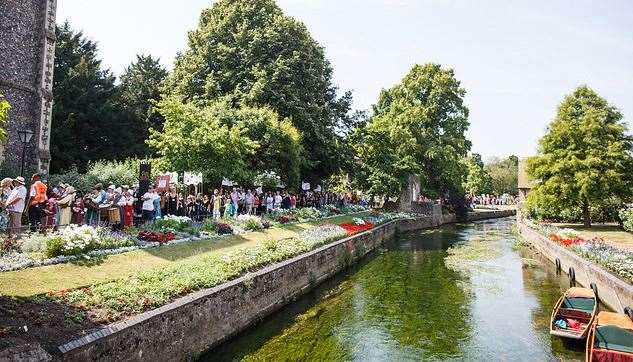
[{"left": 0, "top": 295, "right": 103, "bottom": 353}]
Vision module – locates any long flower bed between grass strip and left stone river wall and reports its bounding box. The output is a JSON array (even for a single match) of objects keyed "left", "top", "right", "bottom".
[{"left": 49, "top": 225, "right": 366, "bottom": 320}]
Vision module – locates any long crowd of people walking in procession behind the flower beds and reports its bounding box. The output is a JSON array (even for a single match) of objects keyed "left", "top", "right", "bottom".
[{"left": 0, "top": 174, "right": 367, "bottom": 236}]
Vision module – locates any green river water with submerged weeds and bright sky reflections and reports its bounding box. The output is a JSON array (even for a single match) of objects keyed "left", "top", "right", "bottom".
[{"left": 202, "top": 219, "right": 584, "bottom": 361}]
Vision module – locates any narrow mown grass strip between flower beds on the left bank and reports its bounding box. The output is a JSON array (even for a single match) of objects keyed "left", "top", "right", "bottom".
[{"left": 0, "top": 213, "right": 366, "bottom": 297}]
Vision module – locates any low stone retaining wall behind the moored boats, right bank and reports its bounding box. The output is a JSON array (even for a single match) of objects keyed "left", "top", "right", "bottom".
[{"left": 518, "top": 221, "right": 633, "bottom": 313}]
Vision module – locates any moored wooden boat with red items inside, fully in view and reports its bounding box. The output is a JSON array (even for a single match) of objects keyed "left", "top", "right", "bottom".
[{"left": 550, "top": 287, "right": 598, "bottom": 339}]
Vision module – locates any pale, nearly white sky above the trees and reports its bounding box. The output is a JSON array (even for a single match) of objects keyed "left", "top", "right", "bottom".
[{"left": 57, "top": 0, "right": 633, "bottom": 159}]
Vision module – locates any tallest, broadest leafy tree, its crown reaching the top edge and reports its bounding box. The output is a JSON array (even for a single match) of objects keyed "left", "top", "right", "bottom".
[{"left": 165, "top": 0, "right": 353, "bottom": 179}]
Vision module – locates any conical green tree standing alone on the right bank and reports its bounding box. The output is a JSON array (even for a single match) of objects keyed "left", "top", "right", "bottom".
[{"left": 527, "top": 86, "right": 633, "bottom": 227}]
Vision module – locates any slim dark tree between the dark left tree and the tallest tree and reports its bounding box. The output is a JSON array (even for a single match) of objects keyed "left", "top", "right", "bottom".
[{"left": 118, "top": 55, "right": 168, "bottom": 155}]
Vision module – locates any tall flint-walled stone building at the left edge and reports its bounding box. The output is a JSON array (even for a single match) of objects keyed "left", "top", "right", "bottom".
[{"left": 0, "top": 0, "right": 57, "bottom": 173}]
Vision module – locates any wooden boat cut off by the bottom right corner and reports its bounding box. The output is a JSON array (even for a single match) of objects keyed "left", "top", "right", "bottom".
[{"left": 586, "top": 312, "right": 633, "bottom": 362}]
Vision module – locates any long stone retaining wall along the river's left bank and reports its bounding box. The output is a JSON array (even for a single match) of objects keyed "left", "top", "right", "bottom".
[{"left": 13, "top": 210, "right": 514, "bottom": 361}]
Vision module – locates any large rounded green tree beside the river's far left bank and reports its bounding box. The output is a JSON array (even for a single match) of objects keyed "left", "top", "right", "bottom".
[{"left": 353, "top": 64, "right": 470, "bottom": 196}]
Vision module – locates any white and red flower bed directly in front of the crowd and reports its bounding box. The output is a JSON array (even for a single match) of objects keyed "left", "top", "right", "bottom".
[{"left": 0, "top": 207, "right": 372, "bottom": 272}]
